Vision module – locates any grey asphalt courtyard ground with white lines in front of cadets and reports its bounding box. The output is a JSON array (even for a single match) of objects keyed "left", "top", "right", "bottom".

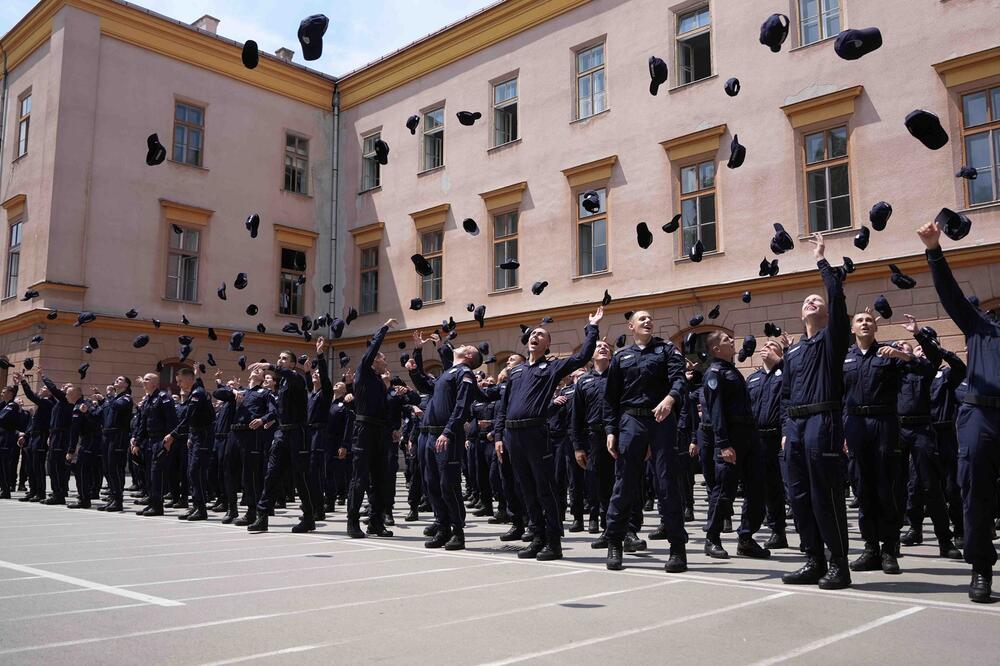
[{"left": 0, "top": 476, "right": 1000, "bottom": 666}]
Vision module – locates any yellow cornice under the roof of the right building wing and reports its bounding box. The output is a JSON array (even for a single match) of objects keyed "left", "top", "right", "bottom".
[{"left": 340, "top": 0, "right": 590, "bottom": 109}]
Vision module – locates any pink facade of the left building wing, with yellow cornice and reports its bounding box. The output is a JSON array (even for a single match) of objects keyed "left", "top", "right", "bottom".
[{"left": 0, "top": 0, "right": 335, "bottom": 389}]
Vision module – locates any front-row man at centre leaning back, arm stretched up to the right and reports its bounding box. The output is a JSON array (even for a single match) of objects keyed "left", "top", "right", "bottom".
[{"left": 494, "top": 307, "right": 604, "bottom": 561}]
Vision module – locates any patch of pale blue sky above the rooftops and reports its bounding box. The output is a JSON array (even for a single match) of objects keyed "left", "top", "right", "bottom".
[{"left": 0, "top": 0, "right": 494, "bottom": 76}]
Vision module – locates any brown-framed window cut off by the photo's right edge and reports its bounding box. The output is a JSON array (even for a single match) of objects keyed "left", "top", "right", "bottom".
[{"left": 962, "top": 88, "right": 1000, "bottom": 206}]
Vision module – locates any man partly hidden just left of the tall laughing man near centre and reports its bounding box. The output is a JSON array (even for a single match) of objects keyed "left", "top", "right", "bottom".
[{"left": 570, "top": 340, "right": 615, "bottom": 536}]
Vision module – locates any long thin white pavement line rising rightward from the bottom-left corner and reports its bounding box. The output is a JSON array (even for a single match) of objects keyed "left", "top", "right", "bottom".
[{"left": 0, "top": 571, "right": 584, "bottom": 655}]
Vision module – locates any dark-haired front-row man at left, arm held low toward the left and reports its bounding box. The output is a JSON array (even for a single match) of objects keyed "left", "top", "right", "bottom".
[{"left": 163, "top": 368, "right": 215, "bottom": 521}]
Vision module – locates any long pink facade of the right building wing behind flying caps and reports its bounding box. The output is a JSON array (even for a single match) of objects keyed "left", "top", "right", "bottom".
[{"left": 338, "top": 0, "right": 1000, "bottom": 370}]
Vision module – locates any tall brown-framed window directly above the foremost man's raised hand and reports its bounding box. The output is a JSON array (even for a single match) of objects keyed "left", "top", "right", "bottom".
[{"left": 805, "top": 127, "right": 851, "bottom": 233}]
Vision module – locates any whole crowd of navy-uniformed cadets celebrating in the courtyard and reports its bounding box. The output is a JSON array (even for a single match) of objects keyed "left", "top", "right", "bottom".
[{"left": 0, "top": 223, "right": 1000, "bottom": 601}]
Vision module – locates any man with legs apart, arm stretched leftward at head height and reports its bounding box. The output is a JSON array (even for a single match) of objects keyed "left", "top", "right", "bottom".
[{"left": 247, "top": 351, "right": 316, "bottom": 533}]
